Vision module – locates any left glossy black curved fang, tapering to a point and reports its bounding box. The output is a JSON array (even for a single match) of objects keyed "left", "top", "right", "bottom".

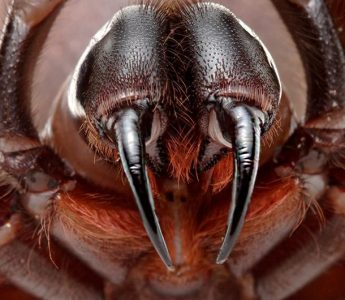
[{"left": 114, "top": 108, "right": 173, "bottom": 269}]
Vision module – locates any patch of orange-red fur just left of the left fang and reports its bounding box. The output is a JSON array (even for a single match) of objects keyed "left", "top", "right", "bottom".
[{"left": 56, "top": 186, "right": 151, "bottom": 252}]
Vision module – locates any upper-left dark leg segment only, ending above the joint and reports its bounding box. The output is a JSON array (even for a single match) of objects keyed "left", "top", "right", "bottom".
[{"left": 0, "top": 0, "right": 65, "bottom": 141}]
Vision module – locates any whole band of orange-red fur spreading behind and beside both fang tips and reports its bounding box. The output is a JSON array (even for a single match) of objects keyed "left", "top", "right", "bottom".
[{"left": 55, "top": 162, "right": 304, "bottom": 281}]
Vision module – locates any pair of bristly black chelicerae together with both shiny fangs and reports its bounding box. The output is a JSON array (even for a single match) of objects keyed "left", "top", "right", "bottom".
[{"left": 69, "top": 3, "right": 281, "bottom": 266}]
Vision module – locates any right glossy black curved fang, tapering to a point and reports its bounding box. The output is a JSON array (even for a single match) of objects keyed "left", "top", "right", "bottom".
[{"left": 217, "top": 103, "right": 264, "bottom": 264}]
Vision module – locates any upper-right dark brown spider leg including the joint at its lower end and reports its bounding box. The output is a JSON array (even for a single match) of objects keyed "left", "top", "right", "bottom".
[{"left": 272, "top": 0, "right": 345, "bottom": 169}]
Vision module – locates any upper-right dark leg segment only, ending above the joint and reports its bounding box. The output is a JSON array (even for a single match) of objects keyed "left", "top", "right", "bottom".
[{"left": 272, "top": 0, "right": 345, "bottom": 123}]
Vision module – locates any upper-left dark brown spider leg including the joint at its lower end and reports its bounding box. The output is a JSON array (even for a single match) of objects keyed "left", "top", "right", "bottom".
[{"left": 0, "top": 0, "right": 70, "bottom": 178}]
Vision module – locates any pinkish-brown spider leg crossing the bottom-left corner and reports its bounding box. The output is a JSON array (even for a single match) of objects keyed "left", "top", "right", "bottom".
[{"left": 0, "top": 215, "right": 102, "bottom": 299}]
